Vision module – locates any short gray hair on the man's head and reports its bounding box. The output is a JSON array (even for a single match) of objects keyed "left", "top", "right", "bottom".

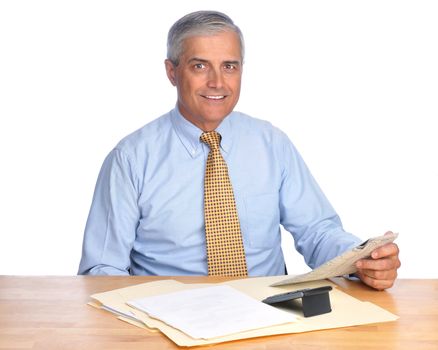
[{"left": 167, "top": 11, "right": 245, "bottom": 66}]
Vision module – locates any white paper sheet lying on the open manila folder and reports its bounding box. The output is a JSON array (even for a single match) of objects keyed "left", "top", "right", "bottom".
[{"left": 127, "top": 285, "right": 296, "bottom": 339}]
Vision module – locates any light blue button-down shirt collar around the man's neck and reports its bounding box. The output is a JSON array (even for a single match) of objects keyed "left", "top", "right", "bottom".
[{"left": 171, "top": 107, "right": 234, "bottom": 158}]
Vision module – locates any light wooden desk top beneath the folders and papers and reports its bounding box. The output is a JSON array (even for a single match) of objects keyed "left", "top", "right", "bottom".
[{"left": 0, "top": 276, "right": 438, "bottom": 350}]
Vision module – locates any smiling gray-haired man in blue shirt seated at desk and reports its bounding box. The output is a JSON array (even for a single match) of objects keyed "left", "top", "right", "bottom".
[{"left": 79, "top": 11, "right": 400, "bottom": 289}]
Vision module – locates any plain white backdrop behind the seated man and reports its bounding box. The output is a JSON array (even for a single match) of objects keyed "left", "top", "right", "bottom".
[{"left": 0, "top": 0, "right": 438, "bottom": 278}]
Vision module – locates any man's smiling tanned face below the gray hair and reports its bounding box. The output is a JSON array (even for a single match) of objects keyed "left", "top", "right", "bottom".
[{"left": 165, "top": 31, "right": 242, "bottom": 131}]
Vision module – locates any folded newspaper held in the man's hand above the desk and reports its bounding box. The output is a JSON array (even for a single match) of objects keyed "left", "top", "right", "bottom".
[{"left": 271, "top": 233, "right": 398, "bottom": 287}]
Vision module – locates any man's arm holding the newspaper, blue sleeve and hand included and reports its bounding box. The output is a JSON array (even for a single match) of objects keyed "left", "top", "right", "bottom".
[{"left": 280, "top": 131, "right": 400, "bottom": 290}]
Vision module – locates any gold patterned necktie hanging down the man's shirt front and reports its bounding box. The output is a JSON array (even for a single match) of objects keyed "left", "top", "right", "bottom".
[{"left": 201, "top": 131, "right": 248, "bottom": 276}]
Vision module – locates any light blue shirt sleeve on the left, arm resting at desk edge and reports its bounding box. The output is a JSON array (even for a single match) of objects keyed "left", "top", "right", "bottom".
[{"left": 78, "top": 148, "right": 139, "bottom": 275}]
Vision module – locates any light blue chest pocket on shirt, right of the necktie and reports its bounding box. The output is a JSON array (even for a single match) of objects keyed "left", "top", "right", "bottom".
[{"left": 243, "top": 193, "right": 280, "bottom": 248}]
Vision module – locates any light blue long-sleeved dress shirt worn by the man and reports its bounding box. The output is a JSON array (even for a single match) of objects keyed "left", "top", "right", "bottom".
[{"left": 79, "top": 108, "right": 360, "bottom": 276}]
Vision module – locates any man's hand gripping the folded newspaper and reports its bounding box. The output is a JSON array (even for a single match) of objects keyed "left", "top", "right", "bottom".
[{"left": 356, "top": 232, "right": 401, "bottom": 290}]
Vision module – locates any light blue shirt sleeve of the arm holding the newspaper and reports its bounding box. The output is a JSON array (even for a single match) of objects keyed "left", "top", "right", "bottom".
[{"left": 280, "top": 133, "right": 361, "bottom": 268}]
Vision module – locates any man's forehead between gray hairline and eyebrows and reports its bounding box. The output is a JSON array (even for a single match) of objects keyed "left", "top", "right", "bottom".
[{"left": 181, "top": 31, "right": 242, "bottom": 61}]
